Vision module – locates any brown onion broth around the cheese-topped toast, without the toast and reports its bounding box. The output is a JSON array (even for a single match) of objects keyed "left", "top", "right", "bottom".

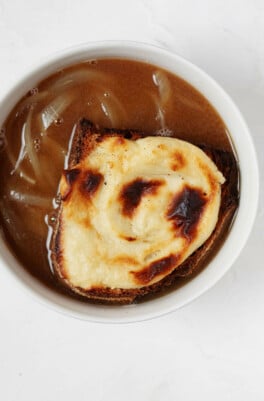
[{"left": 0, "top": 59, "right": 235, "bottom": 296}]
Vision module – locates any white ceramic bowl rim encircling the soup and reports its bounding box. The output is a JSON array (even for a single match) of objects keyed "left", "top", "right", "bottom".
[{"left": 0, "top": 41, "right": 259, "bottom": 323}]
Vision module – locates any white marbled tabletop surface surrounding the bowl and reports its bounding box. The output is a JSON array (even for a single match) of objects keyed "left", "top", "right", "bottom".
[{"left": 0, "top": 0, "right": 264, "bottom": 401}]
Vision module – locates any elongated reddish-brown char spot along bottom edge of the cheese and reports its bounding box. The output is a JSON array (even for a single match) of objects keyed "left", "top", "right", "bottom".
[{"left": 132, "top": 255, "right": 179, "bottom": 285}]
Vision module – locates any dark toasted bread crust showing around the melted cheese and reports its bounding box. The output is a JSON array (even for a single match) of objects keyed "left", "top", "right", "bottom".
[{"left": 51, "top": 118, "right": 239, "bottom": 305}]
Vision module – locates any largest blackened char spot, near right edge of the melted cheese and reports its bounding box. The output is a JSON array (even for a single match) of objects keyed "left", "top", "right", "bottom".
[{"left": 167, "top": 186, "right": 207, "bottom": 239}]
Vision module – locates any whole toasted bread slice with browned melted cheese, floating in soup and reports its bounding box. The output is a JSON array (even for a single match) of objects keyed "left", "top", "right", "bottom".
[{"left": 51, "top": 119, "right": 238, "bottom": 304}]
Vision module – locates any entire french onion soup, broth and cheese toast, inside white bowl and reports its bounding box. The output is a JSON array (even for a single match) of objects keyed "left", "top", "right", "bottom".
[{"left": 0, "top": 59, "right": 238, "bottom": 304}]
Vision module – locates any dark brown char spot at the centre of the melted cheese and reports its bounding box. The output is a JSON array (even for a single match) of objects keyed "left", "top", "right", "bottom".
[{"left": 119, "top": 178, "right": 163, "bottom": 217}]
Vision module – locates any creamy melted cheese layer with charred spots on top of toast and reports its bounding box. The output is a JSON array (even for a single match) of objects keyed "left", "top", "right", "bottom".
[{"left": 56, "top": 136, "right": 224, "bottom": 290}]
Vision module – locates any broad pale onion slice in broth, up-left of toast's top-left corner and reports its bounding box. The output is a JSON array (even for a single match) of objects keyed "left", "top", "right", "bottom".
[{"left": 40, "top": 95, "right": 73, "bottom": 131}]
